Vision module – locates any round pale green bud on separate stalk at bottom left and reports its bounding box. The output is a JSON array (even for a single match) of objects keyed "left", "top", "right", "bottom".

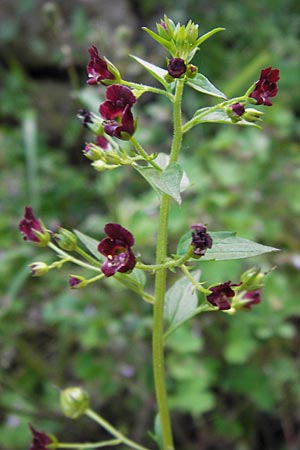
[{"left": 60, "top": 387, "right": 90, "bottom": 419}]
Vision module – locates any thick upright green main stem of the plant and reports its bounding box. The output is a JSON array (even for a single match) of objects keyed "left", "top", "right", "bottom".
[{"left": 152, "top": 80, "right": 184, "bottom": 450}]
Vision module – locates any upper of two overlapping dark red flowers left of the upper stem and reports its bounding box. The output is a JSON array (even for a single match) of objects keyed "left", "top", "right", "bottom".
[{"left": 99, "top": 84, "right": 136, "bottom": 120}]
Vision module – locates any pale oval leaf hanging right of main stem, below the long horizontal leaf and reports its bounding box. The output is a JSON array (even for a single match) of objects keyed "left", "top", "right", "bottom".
[{"left": 164, "top": 270, "right": 201, "bottom": 333}]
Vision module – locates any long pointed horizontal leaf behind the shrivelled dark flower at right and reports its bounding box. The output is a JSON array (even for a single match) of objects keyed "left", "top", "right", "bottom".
[{"left": 177, "top": 231, "right": 279, "bottom": 263}]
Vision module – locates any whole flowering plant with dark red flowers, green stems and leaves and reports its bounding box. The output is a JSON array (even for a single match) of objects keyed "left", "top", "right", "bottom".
[{"left": 19, "top": 16, "right": 279, "bottom": 450}]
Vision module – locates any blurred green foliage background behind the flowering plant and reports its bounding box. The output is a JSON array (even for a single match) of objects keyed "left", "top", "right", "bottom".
[{"left": 0, "top": 0, "right": 300, "bottom": 450}]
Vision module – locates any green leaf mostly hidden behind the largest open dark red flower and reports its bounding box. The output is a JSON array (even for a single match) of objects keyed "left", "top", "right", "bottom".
[{"left": 74, "top": 230, "right": 146, "bottom": 294}]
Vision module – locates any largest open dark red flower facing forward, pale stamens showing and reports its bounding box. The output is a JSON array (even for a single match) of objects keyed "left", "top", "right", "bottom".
[{"left": 98, "top": 223, "right": 136, "bottom": 277}]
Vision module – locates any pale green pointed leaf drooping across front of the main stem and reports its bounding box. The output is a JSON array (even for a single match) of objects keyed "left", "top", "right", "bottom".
[{"left": 135, "top": 163, "right": 183, "bottom": 205}]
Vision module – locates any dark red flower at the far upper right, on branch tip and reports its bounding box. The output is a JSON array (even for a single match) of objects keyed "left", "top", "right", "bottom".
[{"left": 249, "top": 66, "right": 280, "bottom": 106}]
